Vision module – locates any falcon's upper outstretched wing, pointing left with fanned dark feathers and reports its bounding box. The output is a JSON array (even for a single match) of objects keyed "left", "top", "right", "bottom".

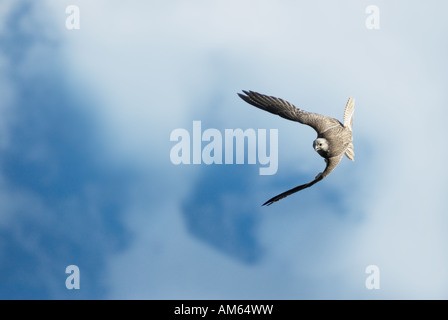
[{"left": 238, "top": 90, "right": 340, "bottom": 134}]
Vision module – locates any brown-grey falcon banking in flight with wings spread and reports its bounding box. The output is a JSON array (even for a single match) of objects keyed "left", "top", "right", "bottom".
[{"left": 238, "top": 90, "right": 355, "bottom": 206}]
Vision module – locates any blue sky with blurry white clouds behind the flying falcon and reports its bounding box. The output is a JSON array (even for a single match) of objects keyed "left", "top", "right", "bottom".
[{"left": 0, "top": 0, "right": 448, "bottom": 300}]
